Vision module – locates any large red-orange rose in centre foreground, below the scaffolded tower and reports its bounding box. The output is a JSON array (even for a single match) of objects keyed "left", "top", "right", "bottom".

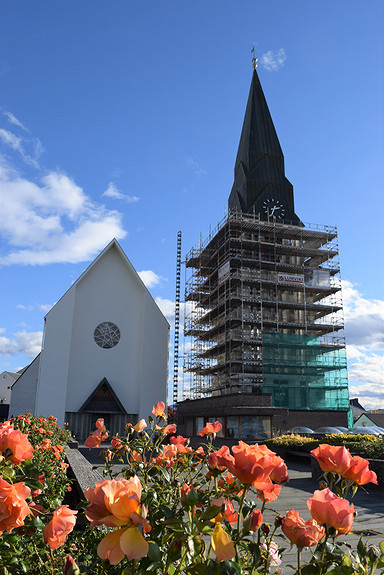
[{"left": 216, "top": 441, "right": 275, "bottom": 489}]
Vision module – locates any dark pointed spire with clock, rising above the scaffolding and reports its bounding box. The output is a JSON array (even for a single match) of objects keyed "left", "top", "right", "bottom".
[{"left": 228, "top": 70, "right": 301, "bottom": 225}]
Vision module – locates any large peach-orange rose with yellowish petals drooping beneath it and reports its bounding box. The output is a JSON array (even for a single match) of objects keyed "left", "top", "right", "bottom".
[{"left": 84, "top": 477, "right": 149, "bottom": 565}]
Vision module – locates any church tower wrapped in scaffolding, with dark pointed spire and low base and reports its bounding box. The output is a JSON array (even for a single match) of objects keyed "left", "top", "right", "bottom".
[{"left": 178, "top": 60, "right": 351, "bottom": 439}]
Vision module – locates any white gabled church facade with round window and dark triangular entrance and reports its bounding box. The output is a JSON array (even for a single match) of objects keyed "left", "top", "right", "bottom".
[{"left": 9, "top": 240, "right": 169, "bottom": 441}]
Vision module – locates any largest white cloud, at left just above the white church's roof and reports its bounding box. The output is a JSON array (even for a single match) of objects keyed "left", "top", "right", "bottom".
[{"left": 0, "top": 166, "right": 126, "bottom": 265}]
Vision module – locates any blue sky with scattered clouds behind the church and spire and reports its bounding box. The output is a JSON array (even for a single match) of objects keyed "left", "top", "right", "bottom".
[{"left": 0, "top": 0, "right": 384, "bottom": 408}]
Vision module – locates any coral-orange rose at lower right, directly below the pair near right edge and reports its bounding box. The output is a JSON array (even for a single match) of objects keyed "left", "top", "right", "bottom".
[{"left": 307, "top": 488, "right": 355, "bottom": 534}]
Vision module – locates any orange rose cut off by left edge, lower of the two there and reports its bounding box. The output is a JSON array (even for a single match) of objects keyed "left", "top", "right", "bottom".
[{"left": 0, "top": 477, "right": 31, "bottom": 535}]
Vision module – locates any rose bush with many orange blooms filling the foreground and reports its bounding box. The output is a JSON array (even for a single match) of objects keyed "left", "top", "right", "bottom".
[{"left": 0, "top": 408, "right": 384, "bottom": 575}]
